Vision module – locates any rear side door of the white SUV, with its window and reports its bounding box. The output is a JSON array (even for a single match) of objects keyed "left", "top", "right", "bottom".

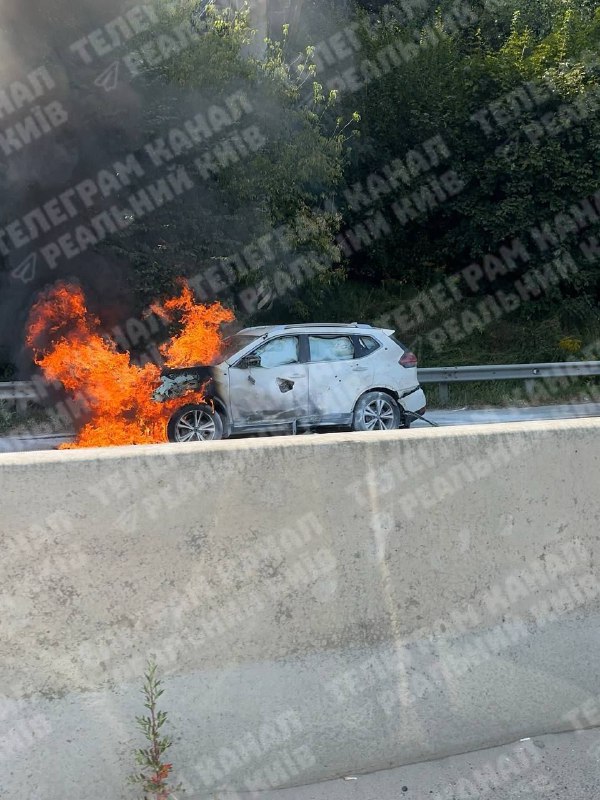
[{"left": 307, "top": 334, "right": 373, "bottom": 424}]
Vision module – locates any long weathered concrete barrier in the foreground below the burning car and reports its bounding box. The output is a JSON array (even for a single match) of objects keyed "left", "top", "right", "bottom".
[{"left": 0, "top": 420, "right": 600, "bottom": 800}]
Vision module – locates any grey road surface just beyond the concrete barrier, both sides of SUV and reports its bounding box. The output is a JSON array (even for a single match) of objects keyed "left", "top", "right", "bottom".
[{"left": 0, "top": 403, "right": 600, "bottom": 453}]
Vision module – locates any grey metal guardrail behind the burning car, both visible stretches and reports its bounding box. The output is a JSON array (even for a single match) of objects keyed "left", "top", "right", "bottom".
[{"left": 0, "top": 361, "right": 600, "bottom": 407}]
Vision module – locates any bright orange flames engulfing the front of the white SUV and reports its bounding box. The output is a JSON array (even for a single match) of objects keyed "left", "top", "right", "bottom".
[{"left": 27, "top": 282, "right": 233, "bottom": 447}]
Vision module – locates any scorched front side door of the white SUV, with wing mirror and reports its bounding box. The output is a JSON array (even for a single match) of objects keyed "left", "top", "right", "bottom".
[{"left": 229, "top": 336, "right": 308, "bottom": 427}]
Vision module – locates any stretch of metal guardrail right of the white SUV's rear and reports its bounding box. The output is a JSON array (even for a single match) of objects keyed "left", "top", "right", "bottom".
[{"left": 419, "top": 361, "right": 600, "bottom": 402}]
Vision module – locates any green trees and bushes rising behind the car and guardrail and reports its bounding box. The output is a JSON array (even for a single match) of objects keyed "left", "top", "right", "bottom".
[{"left": 95, "top": 0, "right": 600, "bottom": 363}]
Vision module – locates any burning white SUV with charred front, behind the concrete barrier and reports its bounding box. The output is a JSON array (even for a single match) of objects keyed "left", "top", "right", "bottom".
[{"left": 153, "top": 322, "right": 425, "bottom": 442}]
